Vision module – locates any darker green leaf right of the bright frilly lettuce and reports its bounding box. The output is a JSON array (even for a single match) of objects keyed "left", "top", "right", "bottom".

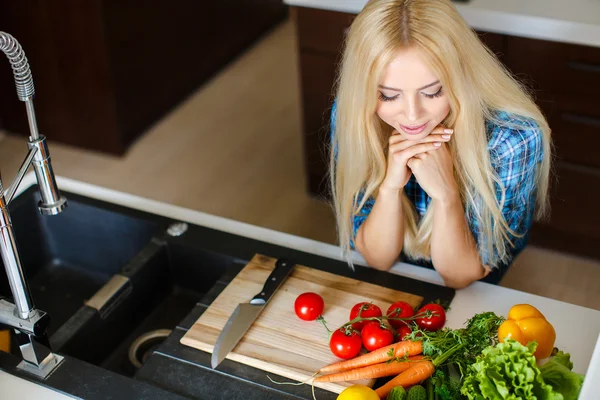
[{"left": 540, "top": 351, "right": 583, "bottom": 400}]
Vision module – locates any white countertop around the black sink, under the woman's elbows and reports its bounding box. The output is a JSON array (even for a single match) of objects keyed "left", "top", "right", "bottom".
[{"left": 0, "top": 173, "right": 600, "bottom": 400}]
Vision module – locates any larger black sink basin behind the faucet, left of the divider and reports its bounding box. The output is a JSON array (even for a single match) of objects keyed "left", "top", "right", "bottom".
[{"left": 0, "top": 190, "right": 158, "bottom": 334}]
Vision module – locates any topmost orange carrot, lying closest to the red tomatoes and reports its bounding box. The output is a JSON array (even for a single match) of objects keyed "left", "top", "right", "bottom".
[{"left": 319, "top": 340, "right": 423, "bottom": 374}]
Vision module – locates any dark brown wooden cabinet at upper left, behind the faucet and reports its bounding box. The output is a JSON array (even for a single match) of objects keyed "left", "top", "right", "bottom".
[{"left": 0, "top": 0, "right": 288, "bottom": 154}]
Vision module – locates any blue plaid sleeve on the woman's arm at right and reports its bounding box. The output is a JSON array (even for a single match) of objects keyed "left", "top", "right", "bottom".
[{"left": 483, "top": 115, "right": 544, "bottom": 265}]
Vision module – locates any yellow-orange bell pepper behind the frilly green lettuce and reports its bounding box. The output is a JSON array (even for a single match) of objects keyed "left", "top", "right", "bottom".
[{"left": 498, "top": 304, "right": 556, "bottom": 360}]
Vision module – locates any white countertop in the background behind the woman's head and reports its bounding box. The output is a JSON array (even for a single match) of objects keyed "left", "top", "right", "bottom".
[{"left": 284, "top": 0, "right": 600, "bottom": 47}]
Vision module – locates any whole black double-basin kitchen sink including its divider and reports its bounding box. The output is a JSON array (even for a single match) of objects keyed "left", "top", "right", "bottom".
[{"left": 0, "top": 188, "right": 239, "bottom": 377}]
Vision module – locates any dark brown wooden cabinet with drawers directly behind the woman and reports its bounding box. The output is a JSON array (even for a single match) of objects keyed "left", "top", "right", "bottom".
[{"left": 292, "top": 7, "right": 600, "bottom": 259}]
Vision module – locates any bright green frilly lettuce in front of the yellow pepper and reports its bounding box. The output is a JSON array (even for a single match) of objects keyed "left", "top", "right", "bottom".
[{"left": 461, "top": 339, "right": 564, "bottom": 400}]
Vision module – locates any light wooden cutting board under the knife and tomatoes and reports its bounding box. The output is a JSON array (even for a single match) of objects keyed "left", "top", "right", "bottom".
[{"left": 181, "top": 255, "right": 423, "bottom": 393}]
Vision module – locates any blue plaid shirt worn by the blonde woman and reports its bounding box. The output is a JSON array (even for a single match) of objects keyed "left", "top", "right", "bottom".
[{"left": 331, "top": 103, "right": 544, "bottom": 272}]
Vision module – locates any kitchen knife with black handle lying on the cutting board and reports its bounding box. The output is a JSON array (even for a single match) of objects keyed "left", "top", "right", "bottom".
[{"left": 210, "top": 259, "right": 294, "bottom": 369}]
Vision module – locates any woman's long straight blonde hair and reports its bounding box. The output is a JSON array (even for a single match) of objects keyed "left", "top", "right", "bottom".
[{"left": 330, "top": 0, "right": 551, "bottom": 266}]
